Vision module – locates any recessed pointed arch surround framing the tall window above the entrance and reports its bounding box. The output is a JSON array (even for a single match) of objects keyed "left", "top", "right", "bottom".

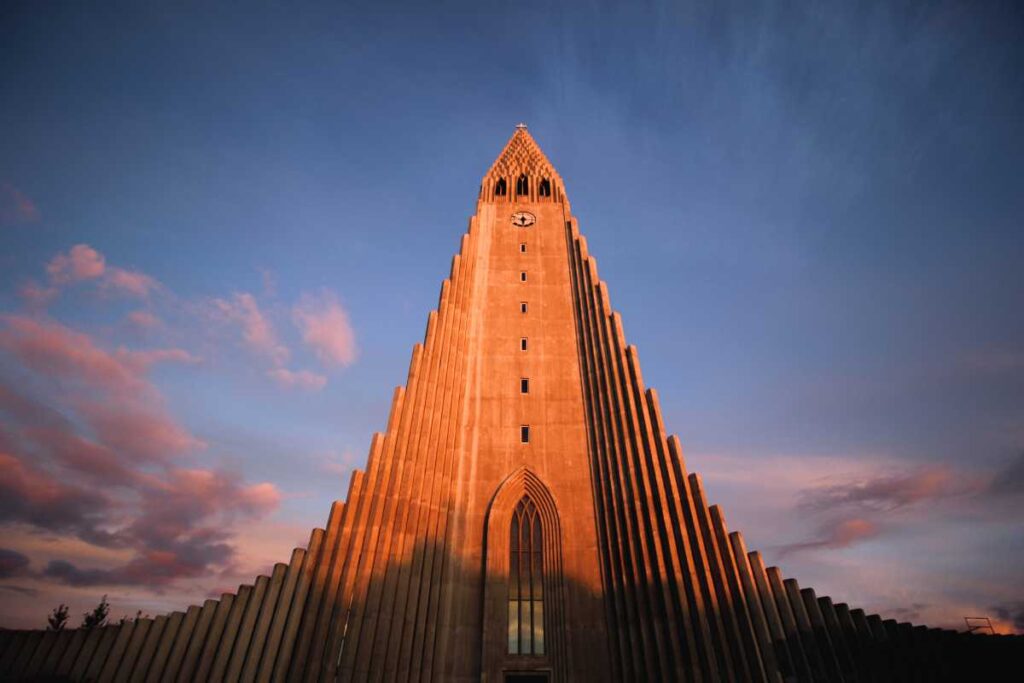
[{"left": 482, "top": 467, "right": 569, "bottom": 681}]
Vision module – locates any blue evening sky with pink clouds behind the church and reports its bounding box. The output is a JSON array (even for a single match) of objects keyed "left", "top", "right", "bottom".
[{"left": 0, "top": 0, "right": 1024, "bottom": 633}]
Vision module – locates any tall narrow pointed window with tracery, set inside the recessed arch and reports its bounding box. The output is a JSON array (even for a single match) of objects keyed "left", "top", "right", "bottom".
[{"left": 509, "top": 496, "right": 544, "bottom": 654}]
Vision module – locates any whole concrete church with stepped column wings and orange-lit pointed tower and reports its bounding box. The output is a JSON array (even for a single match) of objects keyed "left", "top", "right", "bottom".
[{"left": 0, "top": 124, "right": 1021, "bottom": 683}]
